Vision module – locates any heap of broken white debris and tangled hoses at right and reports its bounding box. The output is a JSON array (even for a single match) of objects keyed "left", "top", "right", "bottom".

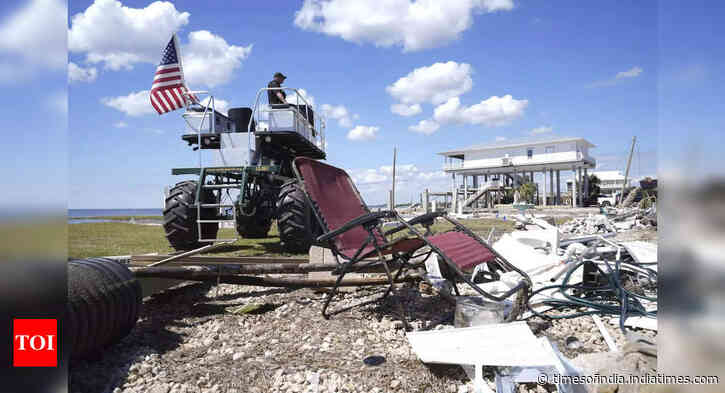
[{"left": 408, "top": 208, "right": 657, "bottom": 392}]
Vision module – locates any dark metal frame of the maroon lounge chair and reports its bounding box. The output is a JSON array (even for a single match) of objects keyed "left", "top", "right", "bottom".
[{"left": 292, "top": 159, "right": 532, "bottom": 319}]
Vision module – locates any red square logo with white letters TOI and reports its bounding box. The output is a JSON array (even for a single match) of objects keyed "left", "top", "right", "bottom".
[{"left": 13, "top": 319, "right": 58, "bottom": 367}]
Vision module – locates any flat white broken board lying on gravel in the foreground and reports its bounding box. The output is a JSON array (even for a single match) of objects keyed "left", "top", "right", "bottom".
[{"left": 406, "top": 321, "right": 556, "bottom": 367}]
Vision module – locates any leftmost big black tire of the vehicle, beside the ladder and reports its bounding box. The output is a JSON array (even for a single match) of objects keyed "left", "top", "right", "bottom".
[{"left": 164, "top": 180, "right": 219, "bottom": 251}]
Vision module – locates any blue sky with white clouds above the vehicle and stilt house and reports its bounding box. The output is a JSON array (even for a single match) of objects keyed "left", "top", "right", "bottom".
[{"left": 0, "top": 0, "right": 723, "bottom": 208}]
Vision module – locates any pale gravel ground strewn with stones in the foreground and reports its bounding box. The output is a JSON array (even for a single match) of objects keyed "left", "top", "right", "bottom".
[{"left": 70, "top": 272, "right": 653, "bottom": 393}]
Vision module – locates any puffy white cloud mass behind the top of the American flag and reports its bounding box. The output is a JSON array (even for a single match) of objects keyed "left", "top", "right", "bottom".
[{"left": 68, "top": 0, "right": 252, "bottom": 88}]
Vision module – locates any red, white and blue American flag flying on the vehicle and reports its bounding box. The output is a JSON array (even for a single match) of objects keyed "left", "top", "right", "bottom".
[{"left": 149, "top": 34, "right": 199, "bottom": 115}]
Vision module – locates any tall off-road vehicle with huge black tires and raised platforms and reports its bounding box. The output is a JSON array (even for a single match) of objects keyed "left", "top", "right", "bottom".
[{"left": 163, "top": 88, "right": 325, "bottom": 253}]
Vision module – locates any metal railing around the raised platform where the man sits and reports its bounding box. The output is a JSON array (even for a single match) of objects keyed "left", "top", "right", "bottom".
[{"left": 248, "top": 87, "right": 325, "bottom": 151}]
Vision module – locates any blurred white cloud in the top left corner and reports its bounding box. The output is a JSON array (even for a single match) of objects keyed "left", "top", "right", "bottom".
[{"left": 0, "top": 0, "right": 68, "bottom": 82}]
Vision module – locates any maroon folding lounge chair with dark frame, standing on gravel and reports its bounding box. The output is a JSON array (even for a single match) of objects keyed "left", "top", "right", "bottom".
[{"left": 293, "top": 157, "right": 531, "bottom": 318}]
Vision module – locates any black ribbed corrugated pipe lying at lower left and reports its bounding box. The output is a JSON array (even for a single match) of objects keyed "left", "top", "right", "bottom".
[{"left": 66, "top": 258, "right": 141, "bottom": 359}]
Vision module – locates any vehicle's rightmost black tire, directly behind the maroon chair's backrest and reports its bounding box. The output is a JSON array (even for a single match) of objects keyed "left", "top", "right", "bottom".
[{"left": 277, "top": 180, "right": 322, "bottom": 254}]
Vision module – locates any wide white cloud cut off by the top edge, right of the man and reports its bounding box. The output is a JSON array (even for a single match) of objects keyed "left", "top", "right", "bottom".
[{"left": 294, "top": 0, "right": 514, "bottom": 52}]
